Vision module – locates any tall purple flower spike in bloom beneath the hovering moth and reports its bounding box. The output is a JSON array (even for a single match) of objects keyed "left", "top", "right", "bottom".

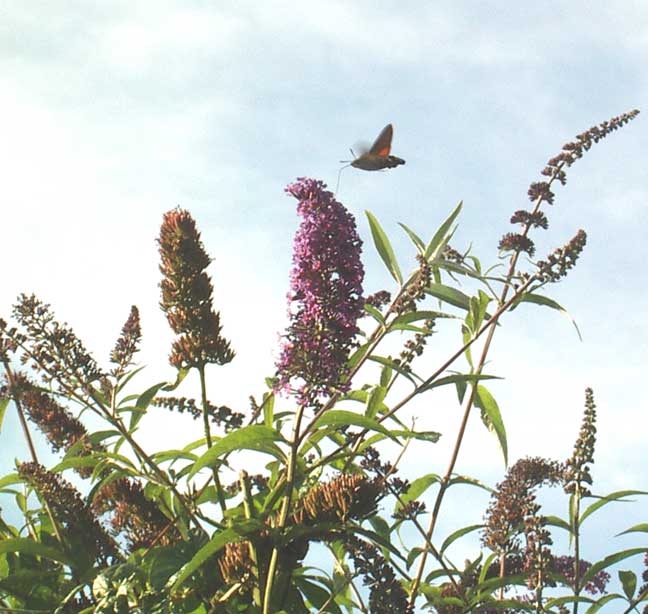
[{"left": 277, "top": 178, "right": 364, "bottom": 404}]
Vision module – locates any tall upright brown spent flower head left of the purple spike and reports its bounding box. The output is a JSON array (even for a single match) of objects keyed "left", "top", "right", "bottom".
[{"left": 158, "top": 209, "right": 234, "bottom": 368}]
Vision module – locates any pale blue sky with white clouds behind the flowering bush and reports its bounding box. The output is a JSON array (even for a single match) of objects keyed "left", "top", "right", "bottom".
[{"left": 0, "top": 0, "right": 648, "bottom": 608}]
